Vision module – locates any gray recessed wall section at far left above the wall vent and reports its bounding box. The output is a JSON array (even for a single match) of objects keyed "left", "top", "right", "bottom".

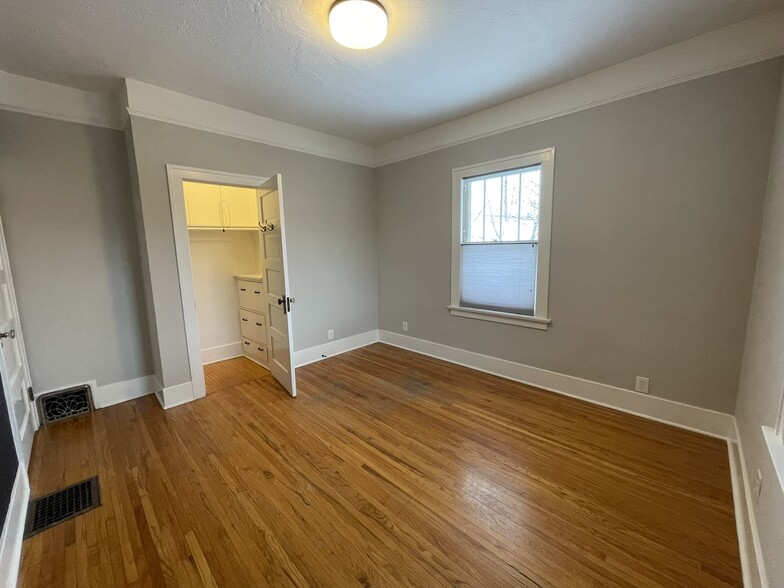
[{"left": 0, "top": 111, "right": 152, "bottom": 391}]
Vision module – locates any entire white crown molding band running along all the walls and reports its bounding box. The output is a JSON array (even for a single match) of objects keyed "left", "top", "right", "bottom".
[{"left": 0, "top": 9, "right": 784, "bottom": 167}]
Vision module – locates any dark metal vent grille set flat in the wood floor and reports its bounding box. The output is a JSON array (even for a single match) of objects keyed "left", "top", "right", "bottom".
[{"left": 25, "top": 476, "right": 101, "bottom": 539}]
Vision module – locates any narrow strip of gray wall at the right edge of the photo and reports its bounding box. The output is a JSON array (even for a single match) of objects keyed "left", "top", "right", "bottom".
[{"left": 735, "top": 73, "right": 784, "bottom": 587}]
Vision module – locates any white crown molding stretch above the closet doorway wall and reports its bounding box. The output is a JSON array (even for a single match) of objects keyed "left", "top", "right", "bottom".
[{"left": 125, "top": 79, "right": 375, "bottom": 167}]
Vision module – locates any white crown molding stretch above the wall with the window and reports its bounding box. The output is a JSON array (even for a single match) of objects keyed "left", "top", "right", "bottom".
[{"left": 376, "top": 9, "right": 784, "bottom": 166}]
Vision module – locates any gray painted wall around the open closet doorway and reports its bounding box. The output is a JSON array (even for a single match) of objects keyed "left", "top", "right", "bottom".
[{"left": 130, "top": 117, "right": 378, "bottom": 387}]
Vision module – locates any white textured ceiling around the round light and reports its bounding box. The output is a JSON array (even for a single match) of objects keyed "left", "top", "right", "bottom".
[{"left": 0, "top": 0, "right": 784, "bottom": 145}]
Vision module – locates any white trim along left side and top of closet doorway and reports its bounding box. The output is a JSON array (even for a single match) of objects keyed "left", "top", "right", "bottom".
[{"left": 166, "top": 164, "right": 269, "bottom": 400}]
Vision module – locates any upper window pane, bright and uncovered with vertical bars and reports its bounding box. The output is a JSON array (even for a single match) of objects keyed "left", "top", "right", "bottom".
[{"left": 463, "top": 165, "right": 542, "bottom": 243}]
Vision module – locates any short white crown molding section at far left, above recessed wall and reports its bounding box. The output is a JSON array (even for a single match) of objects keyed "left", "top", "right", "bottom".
[{"left": 0, "top": 71, "right": 122, "bottom": 129}]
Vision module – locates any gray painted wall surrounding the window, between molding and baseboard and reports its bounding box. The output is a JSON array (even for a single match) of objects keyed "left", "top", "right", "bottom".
[{"left": 378, "top": 61, "right": 781, "bottom": 413}]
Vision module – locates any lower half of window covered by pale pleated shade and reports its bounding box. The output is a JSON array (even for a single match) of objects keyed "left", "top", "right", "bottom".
[{"left": 460, "top": 243, "right": 539, "bottom": 315}]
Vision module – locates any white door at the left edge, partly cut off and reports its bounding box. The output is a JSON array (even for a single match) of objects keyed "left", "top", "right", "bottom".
[{"left": 0, "top": 215, "right": 37, "bottom": 466}]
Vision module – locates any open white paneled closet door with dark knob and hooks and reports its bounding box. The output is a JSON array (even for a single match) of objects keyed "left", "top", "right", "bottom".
[{"left": 257, "top": 174, "right": 297, "bottom": 396}]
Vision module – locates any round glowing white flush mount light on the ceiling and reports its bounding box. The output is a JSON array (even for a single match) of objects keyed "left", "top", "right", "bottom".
[{"left": 329, "top": 0, "right": 388, "bottom": 49}]
